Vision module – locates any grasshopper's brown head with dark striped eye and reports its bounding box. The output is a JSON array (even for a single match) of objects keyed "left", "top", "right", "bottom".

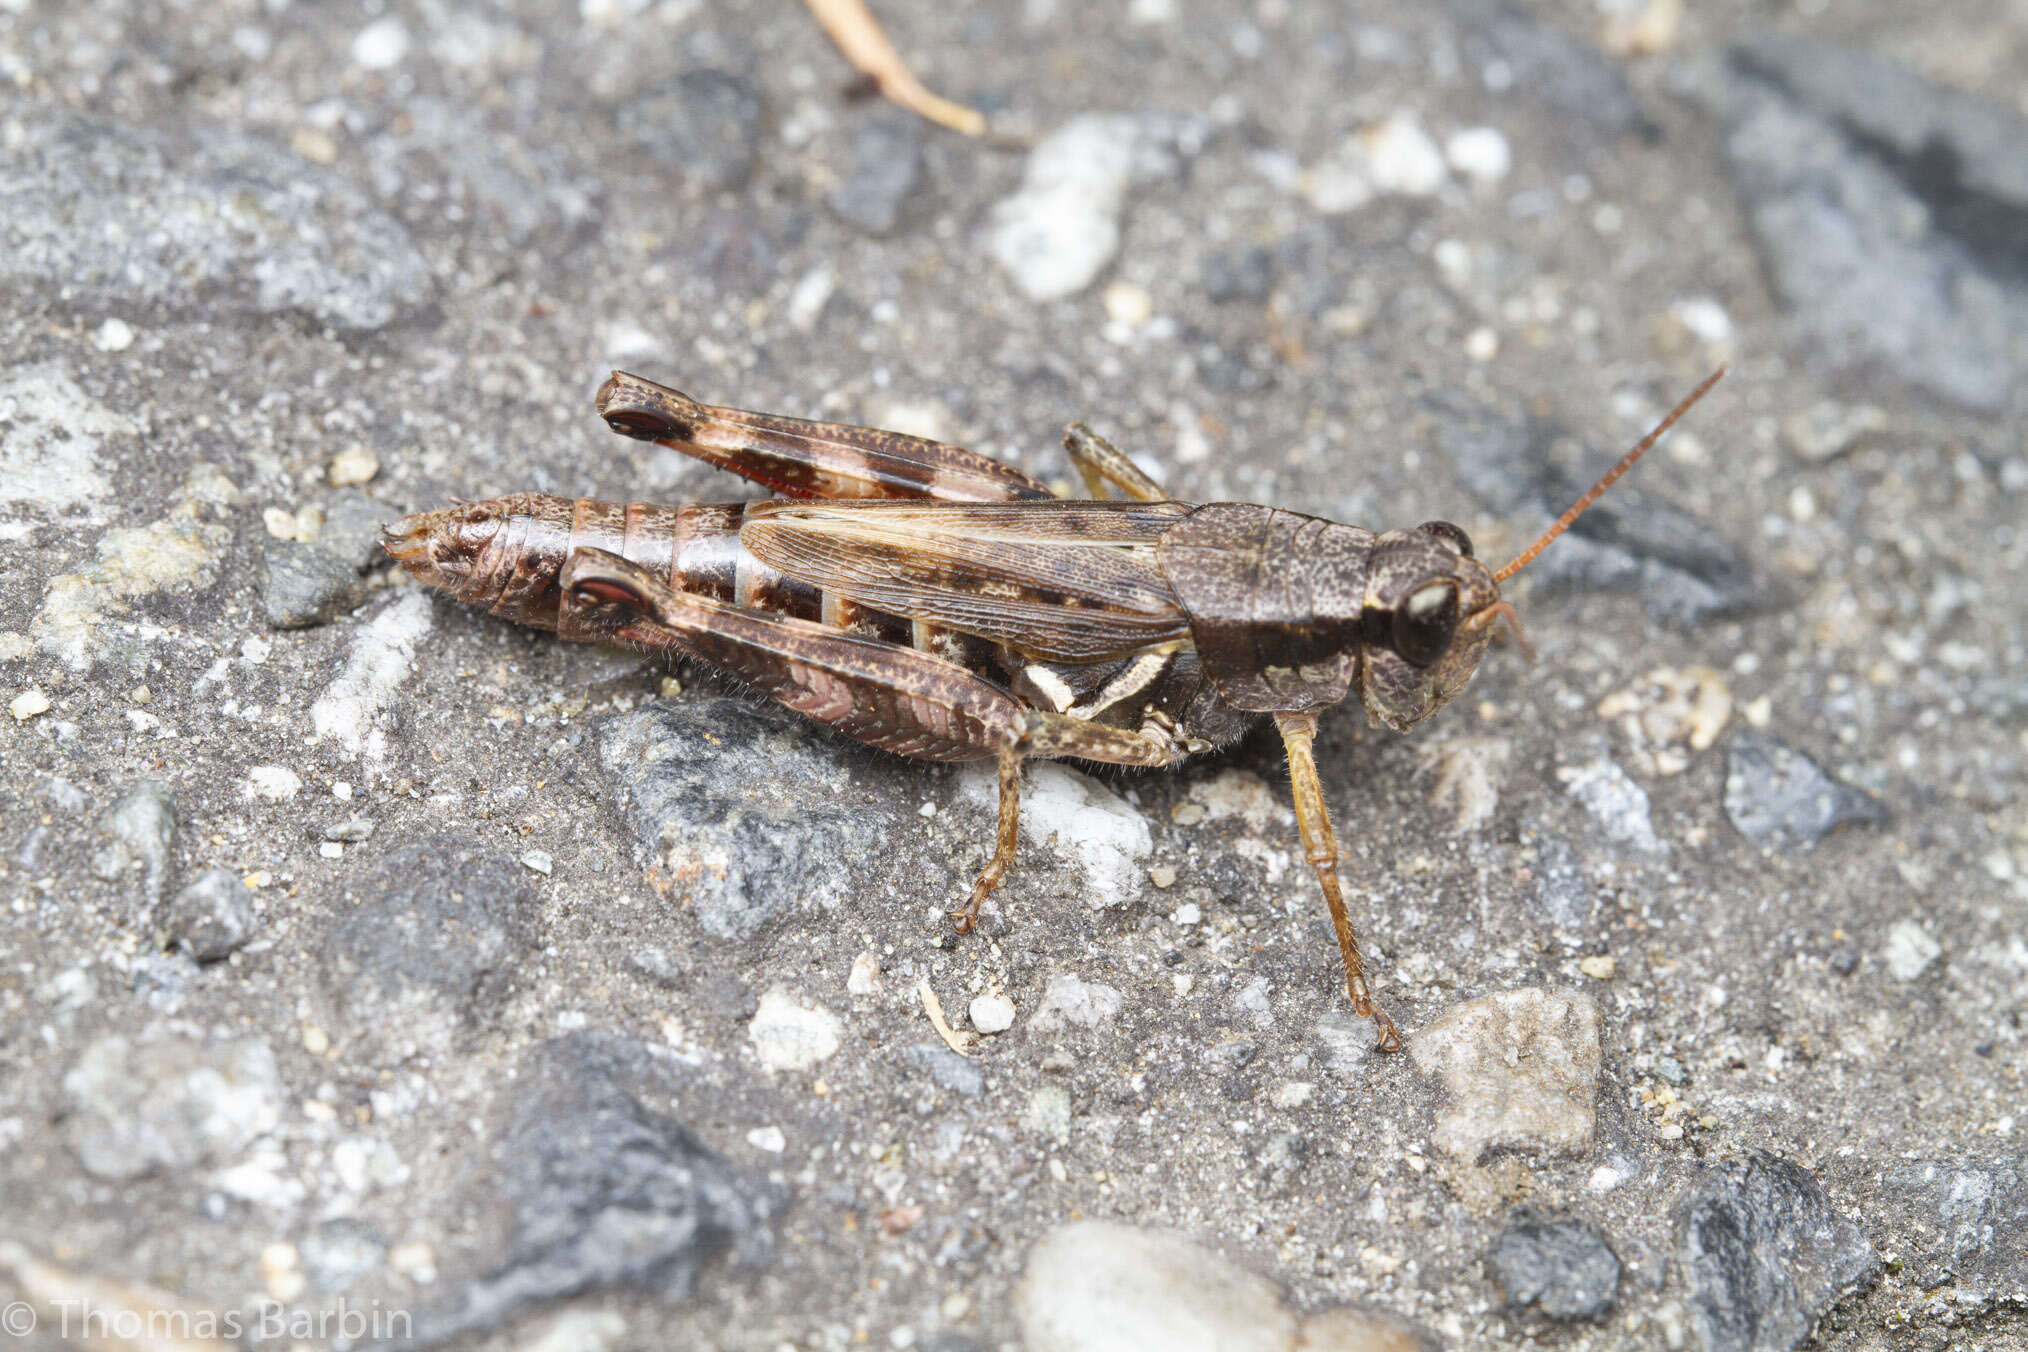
[{"left": 1359, "top": 521, "right": 1513, "bottom": 732}]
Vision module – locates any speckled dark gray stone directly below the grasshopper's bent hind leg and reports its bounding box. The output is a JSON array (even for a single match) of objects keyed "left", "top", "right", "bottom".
[{"left": 598, "top": 697, "right": 892, "bottom": 938}]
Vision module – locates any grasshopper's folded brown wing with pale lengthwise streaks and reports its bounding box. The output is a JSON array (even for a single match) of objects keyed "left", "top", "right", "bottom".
[{"left": 740, "top": 501, "right": 1190, "bottom": 663}]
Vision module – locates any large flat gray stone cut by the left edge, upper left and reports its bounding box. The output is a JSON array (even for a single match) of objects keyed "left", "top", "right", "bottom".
[{"left": 0, "top": 101, "right": 432, "bottom": 330}]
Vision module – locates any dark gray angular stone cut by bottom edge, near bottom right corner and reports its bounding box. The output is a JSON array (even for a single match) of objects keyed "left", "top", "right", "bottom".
[{"left": 1675, "top": 1151, "right": 1880, "bottom": 1352}]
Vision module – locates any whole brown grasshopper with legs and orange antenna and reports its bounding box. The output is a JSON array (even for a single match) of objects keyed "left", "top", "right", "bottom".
[{"left": 383, "top": 367, "right": 1724, "bottom": 1050}]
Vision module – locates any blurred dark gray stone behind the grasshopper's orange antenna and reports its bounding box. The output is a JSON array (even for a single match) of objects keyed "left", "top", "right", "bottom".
[{"left": 1436, "top": 401, "right": 1779, "bottom": 628}]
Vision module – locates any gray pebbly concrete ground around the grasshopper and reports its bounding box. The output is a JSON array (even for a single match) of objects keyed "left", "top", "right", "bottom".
[{"left": 0, "top": 0, "right": 2028, "bottom": 1352}]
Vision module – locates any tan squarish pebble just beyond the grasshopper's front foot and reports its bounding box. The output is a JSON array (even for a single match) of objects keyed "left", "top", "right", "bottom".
[{"left": 1409, "top": 987, "right": 1600, "bottom": 1163}]
